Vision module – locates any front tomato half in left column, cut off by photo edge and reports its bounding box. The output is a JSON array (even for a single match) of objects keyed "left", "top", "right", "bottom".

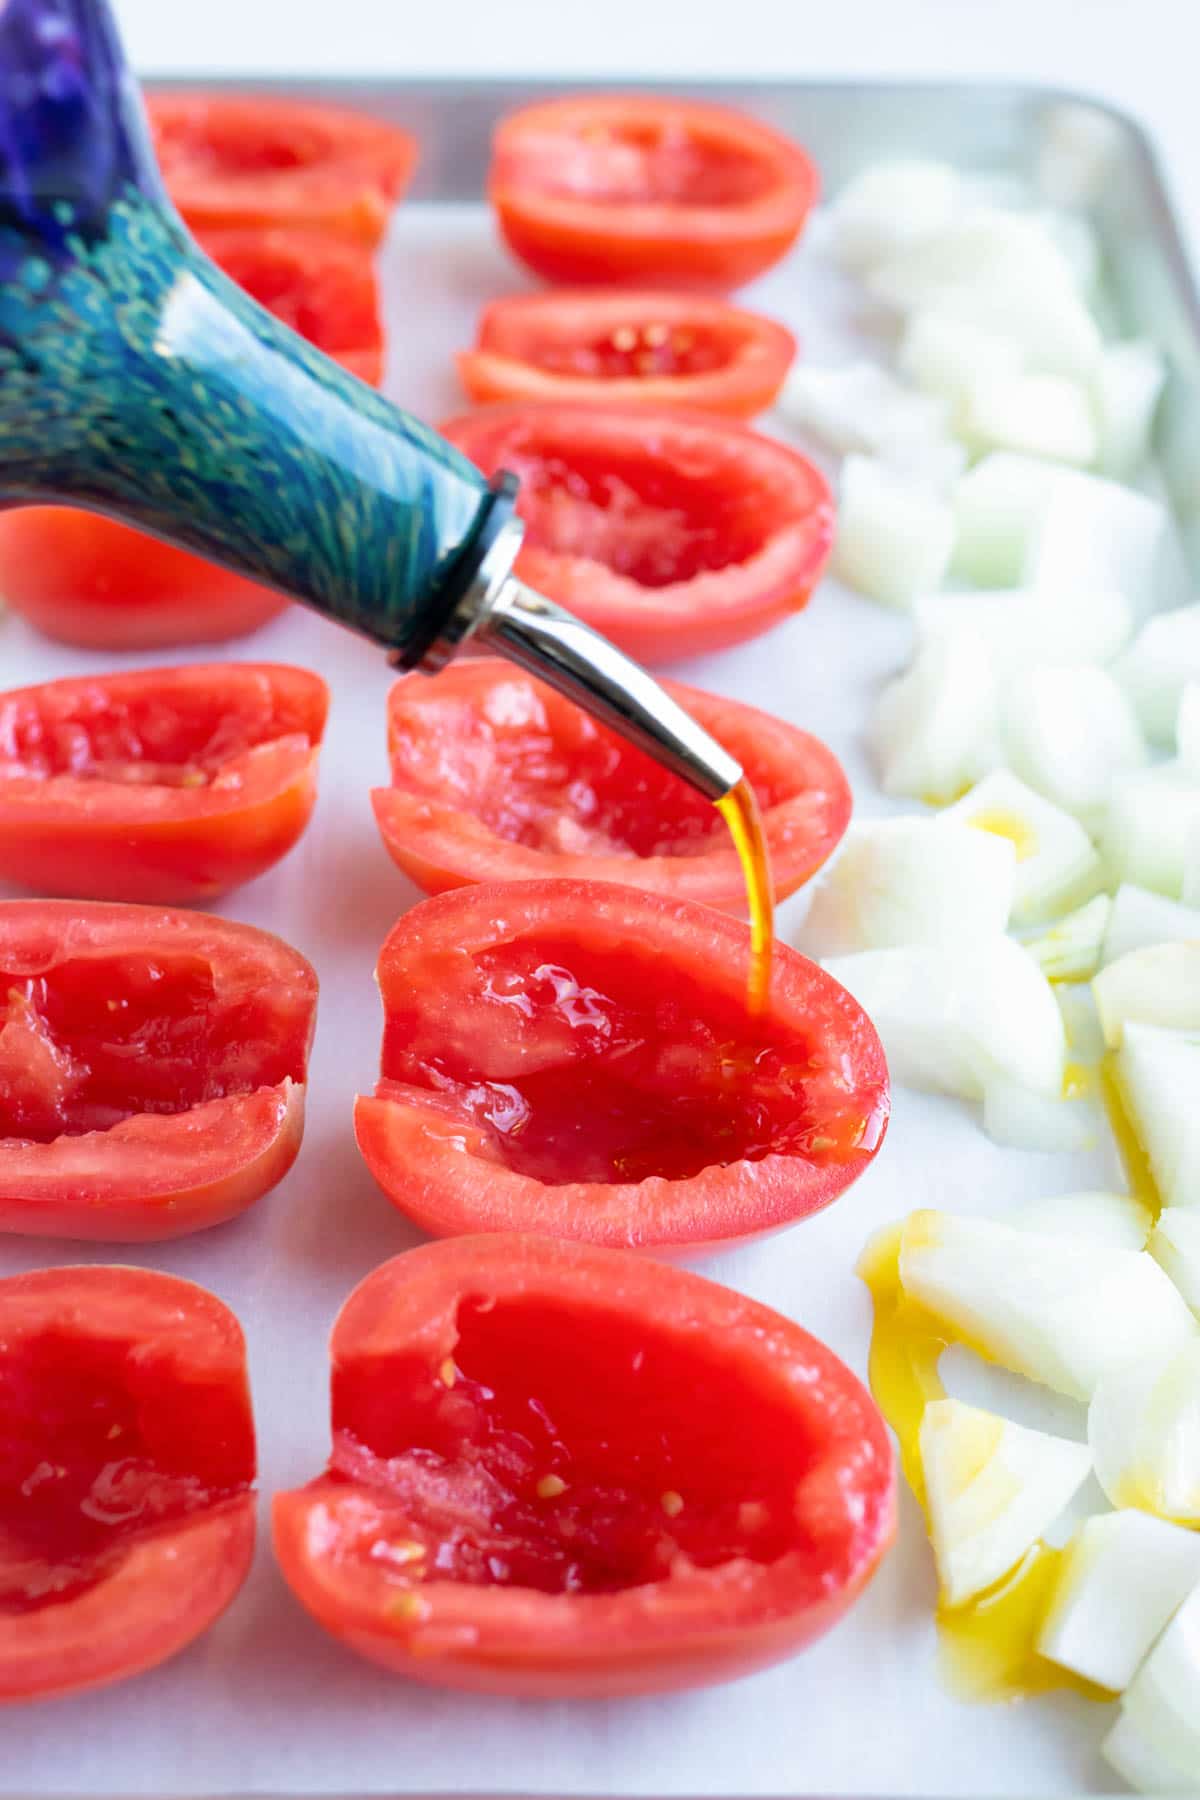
[{"left": 0, "top": 1267, "right": 255, "bottom": 1701}]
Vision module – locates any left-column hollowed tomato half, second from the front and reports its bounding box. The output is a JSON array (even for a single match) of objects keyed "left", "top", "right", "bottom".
[{"left": 0, "top": 900, "right": 317, "bottom": 1244}]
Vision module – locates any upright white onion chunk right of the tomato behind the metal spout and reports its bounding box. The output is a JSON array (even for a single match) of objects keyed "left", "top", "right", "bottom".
[{"left": 869, "top": 637, "right": 1000, "bottom": 805}]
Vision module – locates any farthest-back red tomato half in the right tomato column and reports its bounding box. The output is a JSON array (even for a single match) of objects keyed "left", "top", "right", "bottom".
[{"left": 488, "top": 94, "right": 819, "bottom": 292}]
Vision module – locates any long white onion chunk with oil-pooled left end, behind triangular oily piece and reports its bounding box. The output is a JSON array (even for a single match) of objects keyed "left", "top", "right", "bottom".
[{"left": 900, "top": 1211, "right": 1196, "bottom": 1400}]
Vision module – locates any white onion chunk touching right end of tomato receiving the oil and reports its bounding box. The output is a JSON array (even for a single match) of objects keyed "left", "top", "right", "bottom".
[{"left": 824, "top": 936, "right": 1067, "bottom": 1100}]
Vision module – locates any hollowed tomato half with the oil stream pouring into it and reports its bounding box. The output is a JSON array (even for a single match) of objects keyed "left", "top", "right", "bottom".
[{"left": 354, "top": 880, "right": 889, "bottom": 1247}]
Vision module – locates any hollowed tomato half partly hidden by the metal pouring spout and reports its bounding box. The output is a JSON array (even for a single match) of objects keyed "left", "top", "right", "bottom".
[{"left": 370, "top": 659, "right": 851, "bottom": 911}]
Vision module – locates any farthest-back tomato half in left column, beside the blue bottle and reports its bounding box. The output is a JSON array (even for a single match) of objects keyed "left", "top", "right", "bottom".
[{"left": 148, "top": 90, "right": 417, "bottom": 247}]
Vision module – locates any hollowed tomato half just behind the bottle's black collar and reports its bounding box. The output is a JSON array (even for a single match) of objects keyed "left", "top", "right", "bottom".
[{"left": 443, "top": 401, "right": 833, "bottom": 662}]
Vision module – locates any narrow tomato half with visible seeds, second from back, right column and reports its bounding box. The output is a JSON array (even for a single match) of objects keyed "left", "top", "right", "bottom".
[{"left": 457, "top": 288, "right": 795, "bottom": 419}]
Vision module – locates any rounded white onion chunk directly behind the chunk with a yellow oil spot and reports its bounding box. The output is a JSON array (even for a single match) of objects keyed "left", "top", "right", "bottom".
[{"left": 1002, "top": 666, "right": 1148, "bottom": 832}]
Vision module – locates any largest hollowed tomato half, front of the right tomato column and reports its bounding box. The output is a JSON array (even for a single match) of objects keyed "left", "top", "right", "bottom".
[{"left": 273, "top": 1235, "right": 894, "bottom": 1697}]
